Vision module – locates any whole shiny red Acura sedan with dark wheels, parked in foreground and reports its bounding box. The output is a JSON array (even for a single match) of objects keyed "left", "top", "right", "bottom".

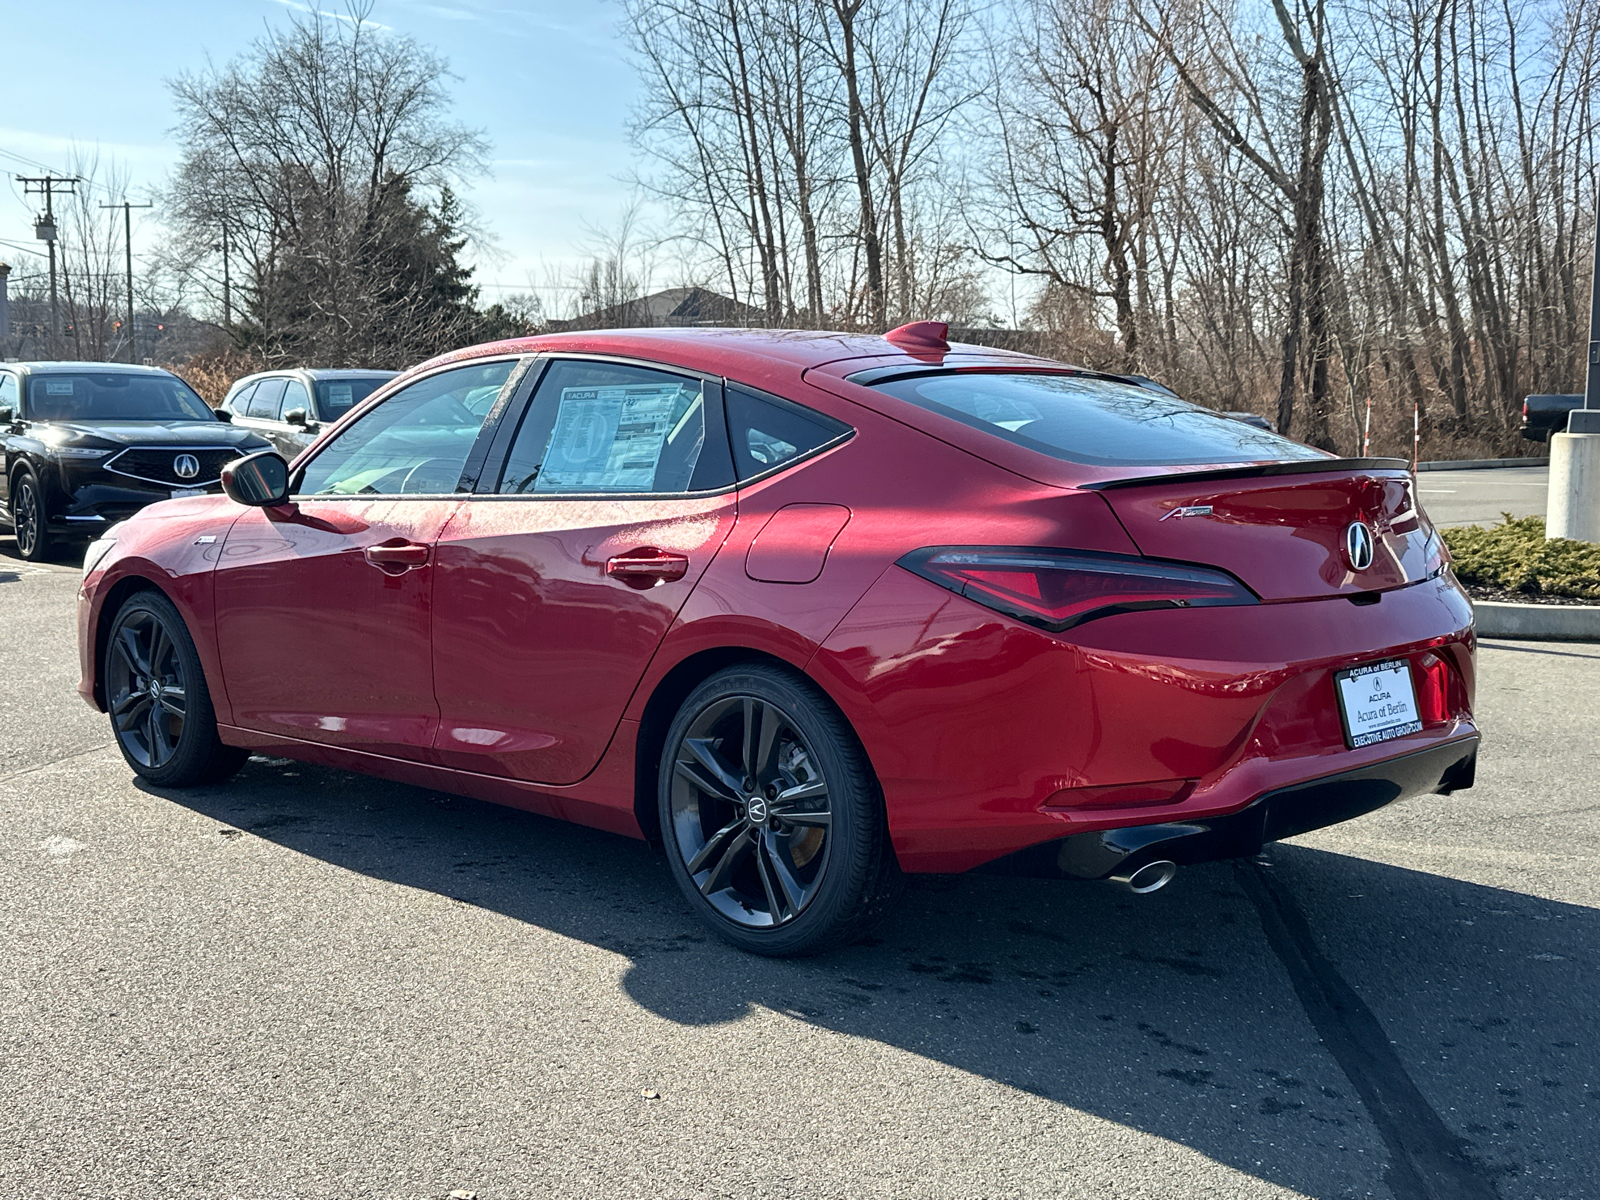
[{"left": 78, "top": 323, "right": 1478, "bottom": 954}]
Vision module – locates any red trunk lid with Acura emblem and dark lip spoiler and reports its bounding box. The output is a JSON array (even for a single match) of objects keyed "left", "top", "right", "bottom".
[{"left": 1088, "top": 462, "right": 1446, "bottom": 600}]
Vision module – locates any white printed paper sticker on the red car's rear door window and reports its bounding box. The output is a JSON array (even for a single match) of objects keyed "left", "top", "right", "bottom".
[{"left": 533, "top": 384, "right": 698, "bottom": 491}]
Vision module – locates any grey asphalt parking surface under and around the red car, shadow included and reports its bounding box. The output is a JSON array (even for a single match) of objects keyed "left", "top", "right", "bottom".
[{"left": 0, "top": 539, "right": 1600, "bottom": 1200}]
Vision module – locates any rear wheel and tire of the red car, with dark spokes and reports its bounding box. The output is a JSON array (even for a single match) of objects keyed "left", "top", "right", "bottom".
[{"left": 658, "top": 666, "right": 901, "bottom": 957}]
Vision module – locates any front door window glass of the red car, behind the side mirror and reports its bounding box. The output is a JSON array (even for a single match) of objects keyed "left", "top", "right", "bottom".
[{"left": 296, "top": 358, "right": 517, "bottom": 496}]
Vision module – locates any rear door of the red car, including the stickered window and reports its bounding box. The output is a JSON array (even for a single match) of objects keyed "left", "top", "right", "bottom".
[{"left": 434, "top": 357, "right": 736, "bottom": 784}]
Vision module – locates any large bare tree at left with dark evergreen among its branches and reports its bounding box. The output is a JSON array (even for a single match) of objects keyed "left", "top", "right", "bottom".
[{"left": 166, "top": 0, "right": 486, "bottom": 365}]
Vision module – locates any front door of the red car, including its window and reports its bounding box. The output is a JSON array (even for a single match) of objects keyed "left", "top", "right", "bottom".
[{"left": 216, "top": 358, "right": 520, "bottom": 757}]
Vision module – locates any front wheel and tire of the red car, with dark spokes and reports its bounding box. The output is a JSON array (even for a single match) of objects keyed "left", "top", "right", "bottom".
[{"left": 101, "top": 592, "right": 250, "bottom": 787}]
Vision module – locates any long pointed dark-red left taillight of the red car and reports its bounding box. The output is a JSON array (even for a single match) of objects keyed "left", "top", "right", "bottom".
[{"left": 899, "top": 546, "right": 1258, "bottom": 634}]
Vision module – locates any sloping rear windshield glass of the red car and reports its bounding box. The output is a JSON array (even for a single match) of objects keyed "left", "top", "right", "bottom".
[{"left": 875, "top": 371, "right": 1326, "bottom": 467}]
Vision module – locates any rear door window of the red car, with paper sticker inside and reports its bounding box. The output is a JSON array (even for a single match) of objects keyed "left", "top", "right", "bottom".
[{"left": 499, "top": 358, "right": 733, "bottom": 496}]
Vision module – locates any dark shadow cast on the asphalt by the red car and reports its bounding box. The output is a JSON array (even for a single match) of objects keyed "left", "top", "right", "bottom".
[{"left": 146, "top": 758, "right": 1600, "bottom": 1197}]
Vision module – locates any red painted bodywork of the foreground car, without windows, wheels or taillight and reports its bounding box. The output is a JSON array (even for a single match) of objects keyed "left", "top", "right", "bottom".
[{"left": 78, "top": 330, "right": 1477, "bottom": 877}]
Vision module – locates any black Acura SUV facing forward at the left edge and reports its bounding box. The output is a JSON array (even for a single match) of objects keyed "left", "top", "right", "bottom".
[{"left": 0, "top": 363, "right": 269, "bottom": 560}]
